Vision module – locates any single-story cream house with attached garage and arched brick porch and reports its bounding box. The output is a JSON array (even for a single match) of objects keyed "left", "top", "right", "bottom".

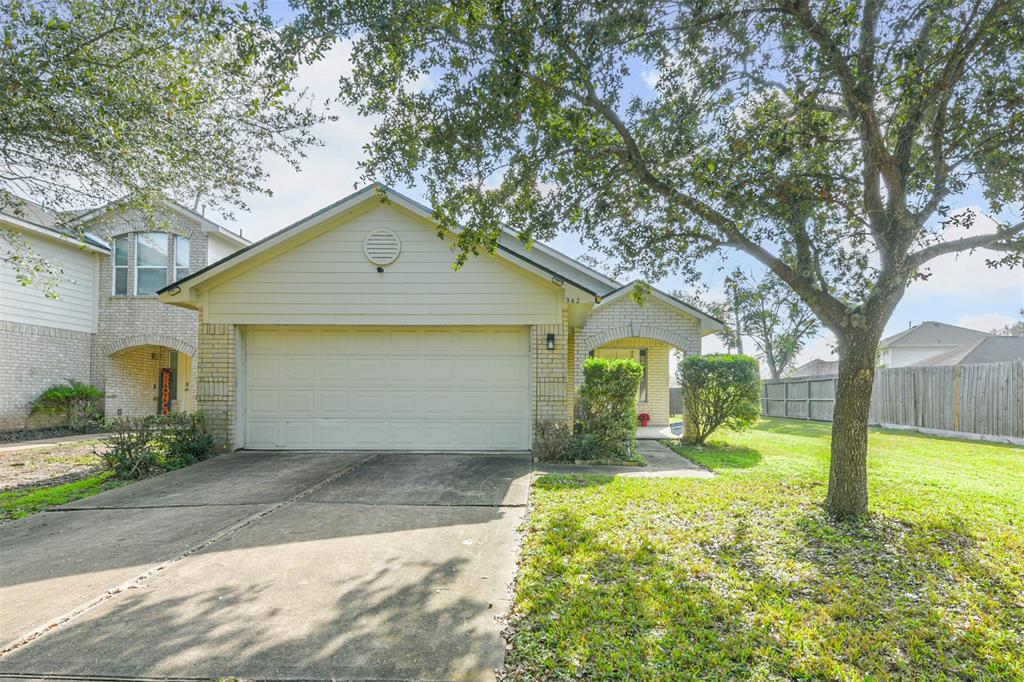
[{"left": 160, "top": 185, "right": 721, "bottom": 451}]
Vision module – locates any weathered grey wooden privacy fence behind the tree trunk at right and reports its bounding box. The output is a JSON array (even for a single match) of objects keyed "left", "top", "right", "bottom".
[{"left": 761, "top": 363, "right": 1024, "bottom": 438}]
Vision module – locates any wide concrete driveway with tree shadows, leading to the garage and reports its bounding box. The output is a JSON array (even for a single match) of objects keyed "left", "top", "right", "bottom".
[{"left": 0, "top": 453, "right": 530, "bottom": 680}]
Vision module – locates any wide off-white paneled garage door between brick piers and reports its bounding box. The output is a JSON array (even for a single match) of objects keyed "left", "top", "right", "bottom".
[{"left": 241, "top": 327, "right": 529, "bottom": 451}]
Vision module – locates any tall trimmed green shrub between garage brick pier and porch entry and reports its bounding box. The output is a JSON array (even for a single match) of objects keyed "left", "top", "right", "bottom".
[{"left": 574, "top": 357, "right": 643, "bottom": 460}]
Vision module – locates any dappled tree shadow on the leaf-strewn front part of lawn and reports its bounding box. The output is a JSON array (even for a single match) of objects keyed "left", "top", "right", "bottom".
[{"left": 507, "top": 491, "right": 1024, "bottom": 680}]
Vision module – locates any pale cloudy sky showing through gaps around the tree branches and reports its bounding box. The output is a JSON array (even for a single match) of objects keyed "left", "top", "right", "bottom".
[{"left": 211, "top": 37, "right": 1024, "bottom": 361}]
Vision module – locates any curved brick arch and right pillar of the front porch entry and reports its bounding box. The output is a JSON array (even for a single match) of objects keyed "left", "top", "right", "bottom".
[{"left": 575, "top": 323, "right": 692, "bottom": 426}]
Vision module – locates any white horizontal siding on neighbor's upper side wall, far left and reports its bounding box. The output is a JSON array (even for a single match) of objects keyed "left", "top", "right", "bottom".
[{"left": 0, "top": 232, "right": 98, "bottom": 332}]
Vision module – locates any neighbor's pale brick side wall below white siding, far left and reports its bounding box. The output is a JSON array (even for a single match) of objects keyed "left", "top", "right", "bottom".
[{"left": 0, "top": 319, "right": 92, "bottom": 431}]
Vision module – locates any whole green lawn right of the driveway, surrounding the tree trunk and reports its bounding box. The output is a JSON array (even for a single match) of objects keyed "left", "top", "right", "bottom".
[{"left": 507, "top": 420, "right": 1024, "bottom": 680}]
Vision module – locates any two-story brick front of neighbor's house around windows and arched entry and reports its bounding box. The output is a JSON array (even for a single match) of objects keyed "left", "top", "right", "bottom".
[{"left": 92, "top": 206, "right": 209, "bottom": 417}]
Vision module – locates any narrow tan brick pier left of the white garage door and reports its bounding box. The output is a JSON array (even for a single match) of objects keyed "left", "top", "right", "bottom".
[{"left": 196, "top": 315, "right": 239, "bottom": 450}]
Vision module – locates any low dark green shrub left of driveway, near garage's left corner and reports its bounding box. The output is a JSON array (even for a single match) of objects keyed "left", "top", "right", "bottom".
[{"left": 99, "top": 413, "right": 214, "bottom": 479}]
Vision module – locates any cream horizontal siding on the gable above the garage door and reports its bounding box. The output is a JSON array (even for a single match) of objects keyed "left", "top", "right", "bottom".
[{"left": 205, "top": 206, "right": 564, "bottom": 325}]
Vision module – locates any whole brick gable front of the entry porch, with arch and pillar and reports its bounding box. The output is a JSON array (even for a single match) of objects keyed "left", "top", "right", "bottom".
[{"left": 572, "top": 296, "right": 700, "bottom": 424}]
